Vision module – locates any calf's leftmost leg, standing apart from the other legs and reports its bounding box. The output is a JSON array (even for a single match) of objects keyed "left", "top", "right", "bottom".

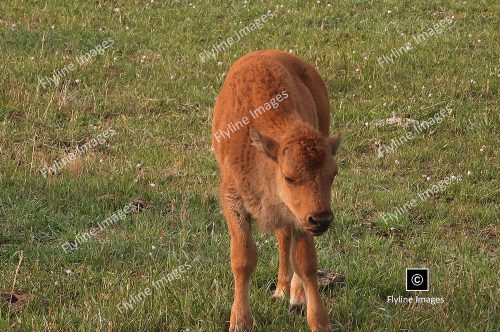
[{"left": 221, "top": 187, "right": 258, "bottom": 332}]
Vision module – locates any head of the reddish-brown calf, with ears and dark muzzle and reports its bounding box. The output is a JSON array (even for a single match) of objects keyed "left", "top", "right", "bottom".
[{"left": 250, "top": 129, "right": 340, "bottom": 235}]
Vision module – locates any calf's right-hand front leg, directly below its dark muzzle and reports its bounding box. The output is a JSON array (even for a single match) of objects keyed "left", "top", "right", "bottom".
[{"left": 291, "top": 230, "right": 331, "bottom": 332}]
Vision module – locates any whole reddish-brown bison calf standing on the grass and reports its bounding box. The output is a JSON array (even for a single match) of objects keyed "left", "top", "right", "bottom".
[{"left": 212, "top": 50, "right": 340, "bottom": 331}]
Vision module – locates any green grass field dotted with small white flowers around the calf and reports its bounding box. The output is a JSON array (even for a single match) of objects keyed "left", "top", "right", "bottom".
[{"left": 0, "top": 0, "right": 500, "bottom": 331}]
